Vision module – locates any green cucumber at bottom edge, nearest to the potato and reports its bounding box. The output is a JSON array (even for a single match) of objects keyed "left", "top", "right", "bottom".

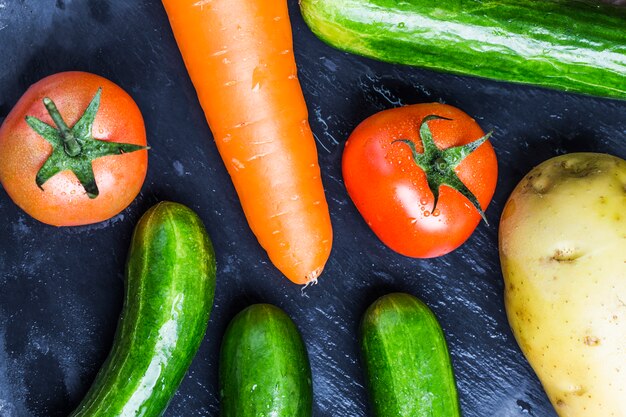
[{"left": 361, "top": 293, "right": 461, "bottom": 417}]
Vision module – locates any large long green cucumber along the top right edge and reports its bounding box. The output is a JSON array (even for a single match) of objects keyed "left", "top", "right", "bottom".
[{"left": 300, "top": 0, "right": 626, "bottom": 100}]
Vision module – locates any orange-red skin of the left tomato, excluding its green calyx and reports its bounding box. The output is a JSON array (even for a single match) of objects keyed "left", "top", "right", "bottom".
[{"left": 0, "top": 72, "right": 148, "bottom": 226}]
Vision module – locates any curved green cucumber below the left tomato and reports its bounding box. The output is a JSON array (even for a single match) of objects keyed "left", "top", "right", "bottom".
[{"left": 70, "top": 202, "right": 216, "bottom": 417}]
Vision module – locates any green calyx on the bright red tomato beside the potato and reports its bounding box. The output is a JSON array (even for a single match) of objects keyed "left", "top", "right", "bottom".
[{"left": 393, "top": 115, "right": 491, "bottom": 224}]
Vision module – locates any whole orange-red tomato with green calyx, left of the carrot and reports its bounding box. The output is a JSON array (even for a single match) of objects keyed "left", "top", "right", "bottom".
[{"left": 0, "top": 72, "right": 148, "bottom": 226}]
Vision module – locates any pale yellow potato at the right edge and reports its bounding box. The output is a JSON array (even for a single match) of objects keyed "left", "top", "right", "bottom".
[{"left": 500, "top": 153, "right": 626, "bottom": 417}]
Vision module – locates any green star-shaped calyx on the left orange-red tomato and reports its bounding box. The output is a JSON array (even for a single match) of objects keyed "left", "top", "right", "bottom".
[{"left": 26, "top": 88, "right": 149, "bottom": 198}]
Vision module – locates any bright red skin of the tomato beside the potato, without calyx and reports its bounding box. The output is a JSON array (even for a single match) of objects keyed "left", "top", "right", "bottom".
[{"left": 342, "top": 103, "right": 498, "bottom": 258}]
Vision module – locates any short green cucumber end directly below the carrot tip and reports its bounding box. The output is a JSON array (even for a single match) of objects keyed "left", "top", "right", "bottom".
[{"left": 219, "top": 304, "right": 313, "bottom": 417}]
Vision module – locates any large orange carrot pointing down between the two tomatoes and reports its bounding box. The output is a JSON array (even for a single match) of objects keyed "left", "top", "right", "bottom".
[{"left": 163, "top": 0, "right": 332, "bottom": 284}]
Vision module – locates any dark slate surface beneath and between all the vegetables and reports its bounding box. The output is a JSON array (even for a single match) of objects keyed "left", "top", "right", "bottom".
[{"left": 0, "top": 0, "right": 626, "bottom": 417}]
